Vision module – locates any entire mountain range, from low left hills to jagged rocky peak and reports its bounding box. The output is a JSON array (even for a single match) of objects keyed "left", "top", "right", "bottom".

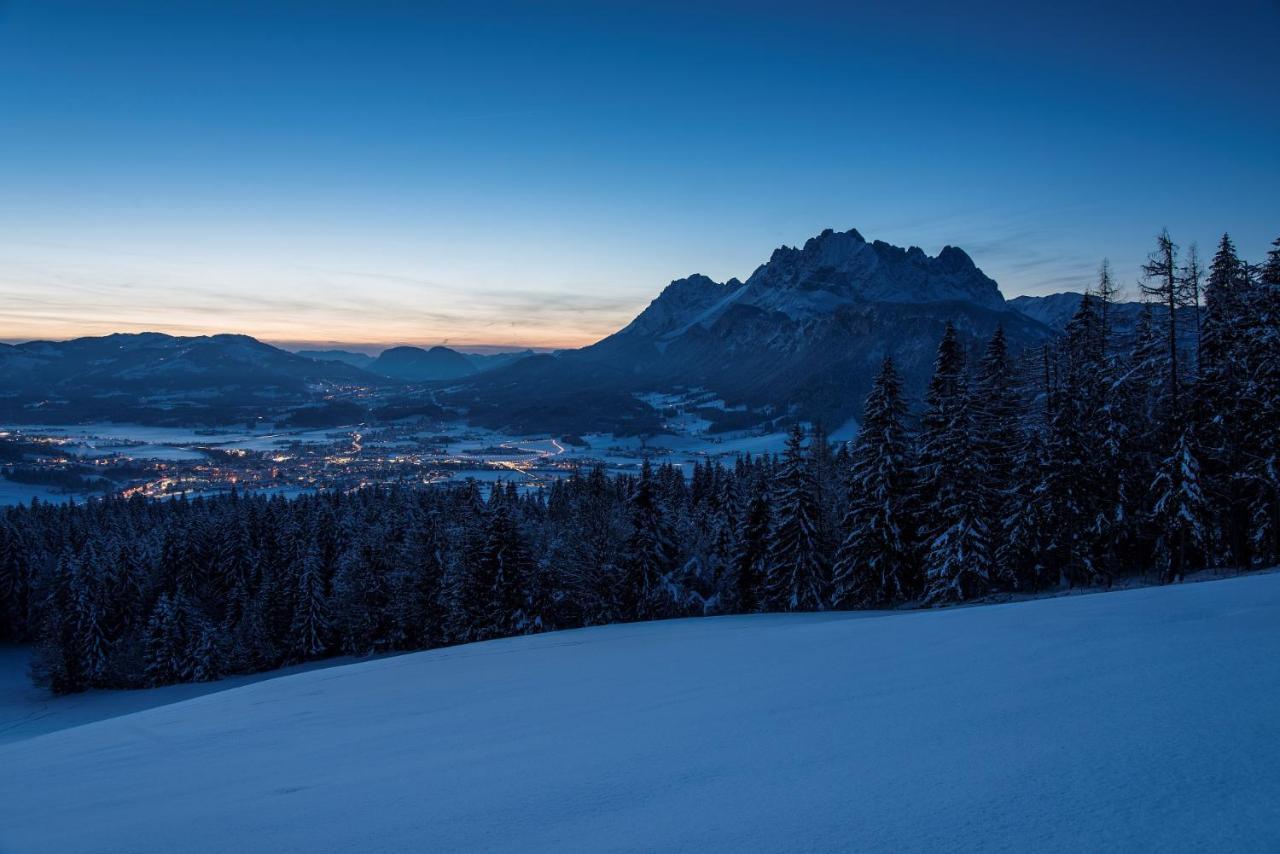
[{"left": 0, "top": 229, "right": 1140, "bottom": 433}]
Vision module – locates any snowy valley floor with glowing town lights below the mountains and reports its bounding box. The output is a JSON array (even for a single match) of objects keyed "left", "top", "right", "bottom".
[{"left": 0, "top": 393, "right": 819, "bottom": 506}]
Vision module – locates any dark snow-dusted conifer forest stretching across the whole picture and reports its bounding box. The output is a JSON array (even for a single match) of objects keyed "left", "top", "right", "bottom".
[{"left": 0, "top": 236, "right": 1280, "bottom": 691}]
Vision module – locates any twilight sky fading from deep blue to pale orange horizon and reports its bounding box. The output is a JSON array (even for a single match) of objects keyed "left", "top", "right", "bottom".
[{"left": 0, "top": 0, "right": 1280, "bottom": 346}]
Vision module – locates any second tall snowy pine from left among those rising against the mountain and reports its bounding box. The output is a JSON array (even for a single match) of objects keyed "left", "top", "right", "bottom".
[{"left": 919, "top": 323, "right": 995, "bottom": 604}]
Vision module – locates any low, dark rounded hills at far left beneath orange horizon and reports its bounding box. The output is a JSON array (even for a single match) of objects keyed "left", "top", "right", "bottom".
[{"left": 0, "top": 333, "right": 387, "bottom": 424}]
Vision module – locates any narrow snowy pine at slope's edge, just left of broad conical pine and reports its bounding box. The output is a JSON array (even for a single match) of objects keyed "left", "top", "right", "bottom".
[{"left": 765, "top": 424, "right": 827, "bottom": 611}]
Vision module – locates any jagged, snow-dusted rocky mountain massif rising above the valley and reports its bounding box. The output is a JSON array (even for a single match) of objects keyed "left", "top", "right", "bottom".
[{"left": 456, "top": 230, "right": 1053, "bottom": 430}]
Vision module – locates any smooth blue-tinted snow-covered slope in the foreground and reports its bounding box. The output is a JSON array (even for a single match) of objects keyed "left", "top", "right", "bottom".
[{"left": 0, "top": 575, "right": 1280, "bottom": 854}]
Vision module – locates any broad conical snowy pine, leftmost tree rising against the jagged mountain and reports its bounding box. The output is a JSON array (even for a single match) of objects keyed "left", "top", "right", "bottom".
[{"left": 831, "top": 357, "right": 919, "bottom": 608}]
